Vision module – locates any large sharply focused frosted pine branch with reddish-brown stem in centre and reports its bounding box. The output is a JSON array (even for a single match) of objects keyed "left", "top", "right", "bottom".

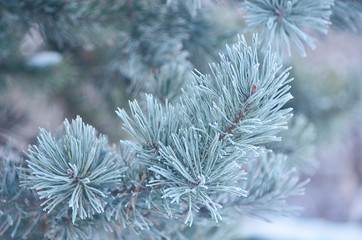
[{"left": 117, "top": 34, "right": 291, "bottom": 225}]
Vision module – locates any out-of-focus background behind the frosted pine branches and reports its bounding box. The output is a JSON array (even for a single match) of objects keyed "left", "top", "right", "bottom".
[{"left": 0, "top": 0, "right": 362, "bottom": 240}]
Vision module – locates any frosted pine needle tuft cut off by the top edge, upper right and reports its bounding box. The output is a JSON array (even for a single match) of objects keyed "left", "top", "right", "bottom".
[{"left": 244, "top": 0, "right": 334, "bottom": 56}]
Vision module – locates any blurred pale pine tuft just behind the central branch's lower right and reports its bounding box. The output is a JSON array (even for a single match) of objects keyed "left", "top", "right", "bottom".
[{"left": 231, "top": 151, "right": 309, "bottom": 219}]
